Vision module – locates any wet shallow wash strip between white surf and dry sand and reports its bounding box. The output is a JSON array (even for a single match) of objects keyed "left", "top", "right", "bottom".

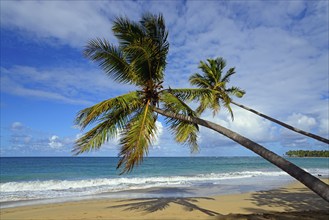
[{"left": 0, "top": 176, "right": 294, "bottom": 209}]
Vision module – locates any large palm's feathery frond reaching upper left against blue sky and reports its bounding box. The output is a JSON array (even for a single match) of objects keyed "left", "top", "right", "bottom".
[{"left": 84, "top": 38, "right": 137, "bottom": 83}]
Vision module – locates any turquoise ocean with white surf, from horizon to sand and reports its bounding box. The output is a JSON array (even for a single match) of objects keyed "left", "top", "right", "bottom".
[{"left": 0, "top": 157, "right": 329, "bottom": 208}]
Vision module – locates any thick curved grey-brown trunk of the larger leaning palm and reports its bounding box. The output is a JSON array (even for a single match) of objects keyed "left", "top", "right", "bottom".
[{"left": 154, "top": 108, "right": 329, "bottom": 202}]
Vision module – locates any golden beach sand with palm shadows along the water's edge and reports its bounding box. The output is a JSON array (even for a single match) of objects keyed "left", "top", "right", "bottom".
[{"left": 0, "top": 179, "right": 329, "bottom": 220}]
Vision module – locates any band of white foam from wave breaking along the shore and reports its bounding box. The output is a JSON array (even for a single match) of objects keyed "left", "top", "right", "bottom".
[{"left": 0, "top": 169, "right": 329, "bottom": 203}]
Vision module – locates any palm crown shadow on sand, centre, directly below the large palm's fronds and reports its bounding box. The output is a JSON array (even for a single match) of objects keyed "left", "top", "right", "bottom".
[{"left": 108, "top": 197, "right": 220, "bottom": 216}]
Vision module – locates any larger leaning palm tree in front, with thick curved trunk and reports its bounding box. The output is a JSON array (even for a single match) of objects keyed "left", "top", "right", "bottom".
[{"left": 73, "top": 14, "right": 329, "bottom": 201}]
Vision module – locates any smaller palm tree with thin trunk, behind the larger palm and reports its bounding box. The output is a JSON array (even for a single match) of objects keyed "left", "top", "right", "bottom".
[{"left": 190, "top": 57, "right": 329, "bottom": 144}]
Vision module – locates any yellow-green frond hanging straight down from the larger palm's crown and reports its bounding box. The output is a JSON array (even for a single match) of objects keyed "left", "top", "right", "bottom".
[{"left": 117, "top": 103, "right": 157, "bottom": 173}]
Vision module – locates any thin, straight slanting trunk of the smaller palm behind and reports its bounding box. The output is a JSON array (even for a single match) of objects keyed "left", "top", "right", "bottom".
[{"left": 231, "top": 101, "right": 329, "bottom": 144}]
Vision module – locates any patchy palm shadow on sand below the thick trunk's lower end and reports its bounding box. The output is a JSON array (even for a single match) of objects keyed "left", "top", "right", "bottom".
[{"left": 248, "top": 188, "right": 329, "bottom": 212}]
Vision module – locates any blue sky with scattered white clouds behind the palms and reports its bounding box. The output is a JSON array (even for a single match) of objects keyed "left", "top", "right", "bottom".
[{"left": 1, "top": 0, "right": 329, "bottom": 156}]
